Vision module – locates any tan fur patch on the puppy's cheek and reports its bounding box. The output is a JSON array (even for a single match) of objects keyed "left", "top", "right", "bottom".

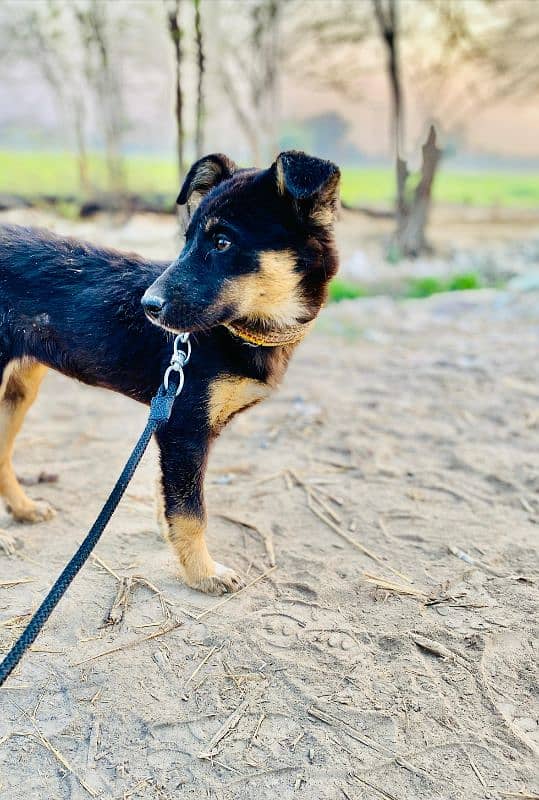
[{"left": 219, "top": 250, "right": 305, "bottom": 328}]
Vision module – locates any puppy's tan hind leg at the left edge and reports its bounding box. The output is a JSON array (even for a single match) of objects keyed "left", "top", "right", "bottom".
[{"left": 0, "top": 361, "right": 54, "bottom": 522}]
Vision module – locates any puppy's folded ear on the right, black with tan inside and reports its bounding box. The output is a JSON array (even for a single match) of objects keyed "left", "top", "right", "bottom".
[{"left": 273, "top": 150, "right": 341, "bottom": 225}]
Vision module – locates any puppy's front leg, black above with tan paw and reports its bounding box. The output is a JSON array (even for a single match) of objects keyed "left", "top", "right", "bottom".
[{"left": 156, "top": 424, "right": 243, "bottom": 594}]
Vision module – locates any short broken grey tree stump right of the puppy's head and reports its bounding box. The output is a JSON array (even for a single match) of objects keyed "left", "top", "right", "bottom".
[{"left": 395, "top": 125, "right": 442, "bottom": 257}]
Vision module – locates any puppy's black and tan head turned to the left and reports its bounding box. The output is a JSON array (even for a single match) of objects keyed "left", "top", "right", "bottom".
[{"left": 142, "top": 151, "right": 340, "bottom": 331}]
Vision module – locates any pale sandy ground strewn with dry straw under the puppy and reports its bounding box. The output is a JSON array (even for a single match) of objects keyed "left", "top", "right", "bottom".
[{"left": 0, "top": 214, "right": 539, "bottom": 800}]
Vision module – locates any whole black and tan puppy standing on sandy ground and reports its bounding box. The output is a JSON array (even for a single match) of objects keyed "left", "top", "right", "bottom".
[{"left": 0, "top": 152, "right": 339, "bottom": 593}]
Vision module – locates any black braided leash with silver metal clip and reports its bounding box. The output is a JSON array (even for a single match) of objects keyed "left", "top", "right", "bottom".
[{"left": 0, "top": 334, "right": 191, "bottom": 686}]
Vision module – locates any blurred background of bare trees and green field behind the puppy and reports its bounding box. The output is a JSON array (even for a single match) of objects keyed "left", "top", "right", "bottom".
[{"left": 0, "top": 0, "right": 539, "bottom": 300}]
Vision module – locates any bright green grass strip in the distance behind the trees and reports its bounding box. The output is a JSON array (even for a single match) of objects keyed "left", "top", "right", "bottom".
[{"left": 0, "top": 150, "right": 539, "bottom": 208}]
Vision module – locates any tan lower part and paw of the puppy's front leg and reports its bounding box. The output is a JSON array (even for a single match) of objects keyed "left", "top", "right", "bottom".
[{"left": 168, "top": 515, "right": 243, "bottom": 594}]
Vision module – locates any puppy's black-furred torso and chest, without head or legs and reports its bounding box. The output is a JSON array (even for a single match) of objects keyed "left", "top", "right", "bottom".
[{"left": 0, "top": 226, "right": 279, "bottom": 406}]
